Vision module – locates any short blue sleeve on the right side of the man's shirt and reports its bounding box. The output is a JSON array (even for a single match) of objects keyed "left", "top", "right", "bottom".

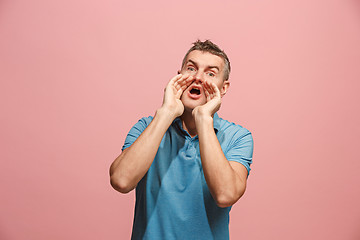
[{"left": 225, "top": 128, "right": 254, "bottom": 175}]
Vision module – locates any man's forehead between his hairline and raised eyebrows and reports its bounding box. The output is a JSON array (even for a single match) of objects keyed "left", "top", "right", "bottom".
[{"left": 185, "top": 50, "right": 225, "bottom": 70}]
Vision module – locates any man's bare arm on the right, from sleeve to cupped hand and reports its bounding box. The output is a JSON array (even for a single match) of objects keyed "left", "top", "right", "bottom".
[{"left": 193, "top": 82, "right": 247, "bottom": 207}]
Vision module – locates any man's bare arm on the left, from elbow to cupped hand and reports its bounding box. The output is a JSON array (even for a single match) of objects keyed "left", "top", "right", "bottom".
[{"left": 110, "top": 74, "right": 192, "bottom": 193}]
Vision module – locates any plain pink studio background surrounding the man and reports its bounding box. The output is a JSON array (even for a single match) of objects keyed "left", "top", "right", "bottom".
[{"left": 0, "top": 0, "right": 360, "bottom": 240}]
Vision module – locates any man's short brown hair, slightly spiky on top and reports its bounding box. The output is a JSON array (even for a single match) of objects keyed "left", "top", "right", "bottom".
[{"left": 181, "top": 40, "right": 231, "bottom": 80}]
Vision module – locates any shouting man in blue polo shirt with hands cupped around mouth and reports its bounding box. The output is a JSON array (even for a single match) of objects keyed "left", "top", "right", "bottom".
[{"left": 110, "top": 40, "right": 253, "bottom": 240}]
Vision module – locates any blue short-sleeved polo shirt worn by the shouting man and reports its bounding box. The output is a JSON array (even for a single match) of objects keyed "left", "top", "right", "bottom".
[{"left": 122, "top": 114, "right": 253, "bottom": 240}]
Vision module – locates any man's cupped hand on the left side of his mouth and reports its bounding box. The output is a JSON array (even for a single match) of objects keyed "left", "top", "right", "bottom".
[{"left": 161, "top": 74, "right": 193, "bottom": 119}]
